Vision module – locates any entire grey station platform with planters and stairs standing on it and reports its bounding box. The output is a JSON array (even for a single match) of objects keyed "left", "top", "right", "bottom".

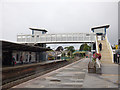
[{"left": 12, "top": 58, "right": 120, "bottom": 90}]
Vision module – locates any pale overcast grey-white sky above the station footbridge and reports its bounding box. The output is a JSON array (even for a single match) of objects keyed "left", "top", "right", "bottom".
[{"left": 0, "top": 0, "right": 119, "bottom": 49}]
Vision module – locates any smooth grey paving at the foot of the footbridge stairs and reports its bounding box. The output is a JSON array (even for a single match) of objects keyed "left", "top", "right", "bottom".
[{"left": 83, "top": 64, "right": 119, "bottom": 88}]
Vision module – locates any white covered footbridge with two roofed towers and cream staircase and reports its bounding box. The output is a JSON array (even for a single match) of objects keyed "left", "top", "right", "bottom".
[{"left": 17, "top": 25, "right": 113, "bottom": 63}]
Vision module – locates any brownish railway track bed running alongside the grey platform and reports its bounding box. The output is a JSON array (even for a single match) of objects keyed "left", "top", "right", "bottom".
[{"left": 2, "top": 60, "right": 82, "bottom": 89}]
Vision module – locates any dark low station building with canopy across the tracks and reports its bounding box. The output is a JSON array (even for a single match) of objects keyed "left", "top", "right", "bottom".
[{"left": 0, "top": 41, "right": 51, "bottom": 66}]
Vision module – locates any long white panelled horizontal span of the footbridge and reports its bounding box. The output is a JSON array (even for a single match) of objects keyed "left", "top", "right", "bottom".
[{"left": 17, "top": 33, "right": 95, "bottom": 43}]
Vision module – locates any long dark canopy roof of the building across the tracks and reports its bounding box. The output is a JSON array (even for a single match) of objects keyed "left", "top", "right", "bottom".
[{"left": 0, "top": 41, "right": 51, "bottom": 52}]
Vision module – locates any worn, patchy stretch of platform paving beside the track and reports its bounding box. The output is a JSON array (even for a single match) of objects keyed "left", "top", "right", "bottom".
[{"left": 13, "top": 59, "right": 89, "bottom": 88}]
